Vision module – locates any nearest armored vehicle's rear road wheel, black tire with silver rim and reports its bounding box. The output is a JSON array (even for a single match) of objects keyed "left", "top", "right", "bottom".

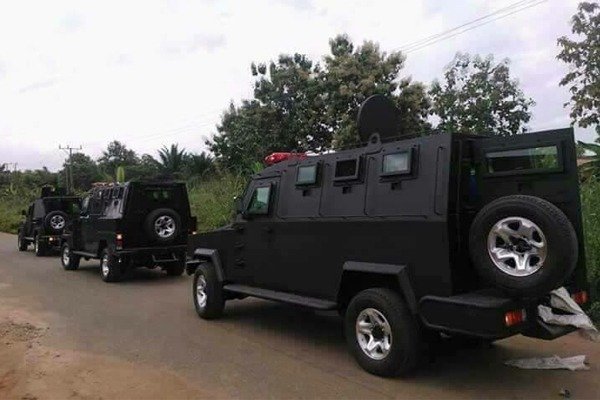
[{"left": 344, "top": 288, "right": 421, "bottom": 377}]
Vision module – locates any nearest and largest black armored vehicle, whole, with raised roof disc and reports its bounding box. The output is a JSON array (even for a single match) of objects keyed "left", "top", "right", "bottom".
[{"left": 187, "top": 97, "right": 587, "bottom": 376}]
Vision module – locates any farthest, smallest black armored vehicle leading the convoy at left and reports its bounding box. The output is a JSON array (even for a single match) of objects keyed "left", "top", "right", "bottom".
[{"left": 17, "top": 186, "right": 81, "bottom": 256}]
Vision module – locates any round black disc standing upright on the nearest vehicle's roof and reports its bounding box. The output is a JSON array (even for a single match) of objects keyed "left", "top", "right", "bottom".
[{"left": 357, "top": 94, "right": 399, "bottom": 142}]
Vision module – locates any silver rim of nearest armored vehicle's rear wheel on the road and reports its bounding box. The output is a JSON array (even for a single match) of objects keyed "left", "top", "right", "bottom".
[{"left": 356, "top": 308, "right": 393, "bottom": 361}]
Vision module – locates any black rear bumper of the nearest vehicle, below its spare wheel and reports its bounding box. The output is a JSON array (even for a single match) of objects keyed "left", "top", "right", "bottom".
[{"left": 419, "top": 289, "right": 576, "bottom": 340}]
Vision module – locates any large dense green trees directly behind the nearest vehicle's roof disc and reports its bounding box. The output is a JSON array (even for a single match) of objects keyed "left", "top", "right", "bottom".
[{"left": 207, "top": 36, "right": 429, "bottom": 172}]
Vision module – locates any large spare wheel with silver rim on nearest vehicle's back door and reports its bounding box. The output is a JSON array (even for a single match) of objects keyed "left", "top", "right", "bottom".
[{"left": 469, "top": 195, "right": 578, "bottom": 297}]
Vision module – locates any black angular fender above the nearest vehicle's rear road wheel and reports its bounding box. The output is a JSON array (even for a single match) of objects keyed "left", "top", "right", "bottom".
[{"left": 337, "top": 261, "right": 417, "bottom": 314}]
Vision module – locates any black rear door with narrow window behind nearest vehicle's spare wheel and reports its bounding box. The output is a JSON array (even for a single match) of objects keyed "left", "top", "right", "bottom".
[{"left": 472, "top": 128, "right": 585, "bottom": 282}]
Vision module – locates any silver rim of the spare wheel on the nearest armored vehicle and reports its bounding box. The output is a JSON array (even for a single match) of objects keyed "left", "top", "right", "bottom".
[{"left": 487, "top": 217, "right": 548, "bottom": 277}]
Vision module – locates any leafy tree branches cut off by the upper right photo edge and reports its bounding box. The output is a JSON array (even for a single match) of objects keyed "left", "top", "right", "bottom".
[{"left": 557, "top": 2, "right": 600, "bottom": 135}]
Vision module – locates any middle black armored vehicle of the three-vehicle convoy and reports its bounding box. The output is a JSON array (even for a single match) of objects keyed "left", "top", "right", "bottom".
[{"left": 61, "top": 182, "right": 196, "bottom": 282}]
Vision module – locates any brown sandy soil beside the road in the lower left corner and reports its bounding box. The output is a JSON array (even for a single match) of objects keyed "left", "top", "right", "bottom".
[{"left": 0, "top": 306, "right": 207, "bottom": 400}]
